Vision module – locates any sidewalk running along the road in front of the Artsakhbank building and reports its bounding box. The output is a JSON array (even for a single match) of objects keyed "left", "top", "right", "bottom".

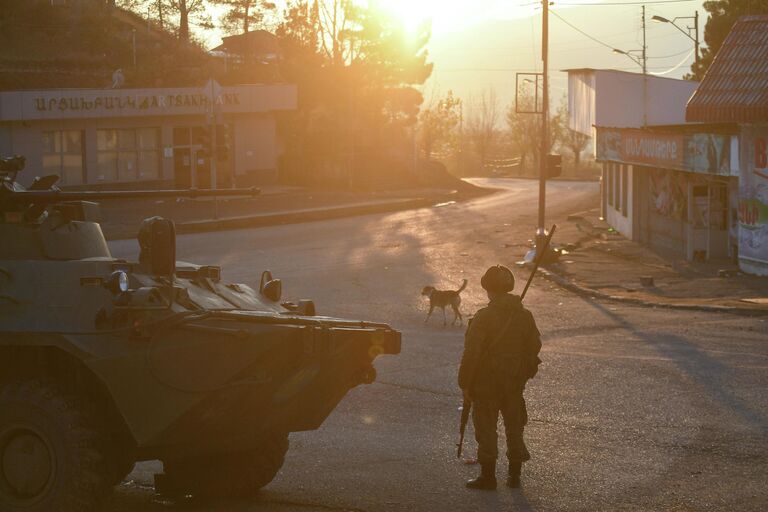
[{"left": 101, "top": 184, "right": 490, "bottom": 240}]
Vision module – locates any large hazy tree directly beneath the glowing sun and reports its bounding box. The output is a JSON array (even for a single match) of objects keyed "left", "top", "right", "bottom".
[{"left": 277, "top": 0, "right": 432, "bottom": 184}]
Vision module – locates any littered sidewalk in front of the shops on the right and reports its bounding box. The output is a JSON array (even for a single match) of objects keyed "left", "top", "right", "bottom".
[{"left": 547, "top": 211, "right": 768, "bottom": 314}]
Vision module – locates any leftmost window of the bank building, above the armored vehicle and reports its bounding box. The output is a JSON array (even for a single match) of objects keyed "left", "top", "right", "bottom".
[{"left": 42, "top": 130, "right": 85, "bottom": 185}]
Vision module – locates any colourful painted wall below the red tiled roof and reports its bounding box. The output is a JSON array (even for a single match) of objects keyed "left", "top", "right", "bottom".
[{"left": 739, "top": 124, "right": 768, "bottom": 275}]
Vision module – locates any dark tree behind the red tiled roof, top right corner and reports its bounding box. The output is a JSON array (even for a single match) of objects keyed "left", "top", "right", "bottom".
[{"left": 686, "top": 0, "right": 768, "bottom": 80}]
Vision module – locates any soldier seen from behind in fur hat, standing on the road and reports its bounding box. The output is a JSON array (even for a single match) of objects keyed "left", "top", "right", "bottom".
[{"left": 459, "top": 265, "right": 541, "bottom": 489}]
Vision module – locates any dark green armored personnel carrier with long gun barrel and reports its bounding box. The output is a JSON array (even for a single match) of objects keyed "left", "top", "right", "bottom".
[{"left": 0, "top": 157, "right": 400, "bottom": 512}]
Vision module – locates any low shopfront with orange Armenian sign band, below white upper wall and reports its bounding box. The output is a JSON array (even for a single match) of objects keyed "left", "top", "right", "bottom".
[{"left": 596, "top": 125, "right": 738, "bottom": 261}]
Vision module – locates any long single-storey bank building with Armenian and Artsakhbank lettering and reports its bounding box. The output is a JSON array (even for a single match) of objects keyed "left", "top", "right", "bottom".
[{"left": 0, "top": 82, "right": 297, "bottom": 189}]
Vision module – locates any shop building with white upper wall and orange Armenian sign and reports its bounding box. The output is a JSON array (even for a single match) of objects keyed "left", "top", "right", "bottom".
[{"left": 568, "top": 69, "right": 739, "bottom": 260}]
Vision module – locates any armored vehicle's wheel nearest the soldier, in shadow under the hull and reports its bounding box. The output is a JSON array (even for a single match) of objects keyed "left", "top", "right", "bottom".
[{"left": 158, "top": 434, "right": 288, "bottom": 498}]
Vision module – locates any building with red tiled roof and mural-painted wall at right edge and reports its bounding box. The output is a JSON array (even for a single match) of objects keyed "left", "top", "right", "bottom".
[{"left": 686, "top": 15, "right": 768, "bottom": 275}]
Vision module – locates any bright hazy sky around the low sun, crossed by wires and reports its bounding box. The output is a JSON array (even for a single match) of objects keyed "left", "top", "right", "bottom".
[{"left": 208, "top": 0, "right": 706, "bottom": 114}]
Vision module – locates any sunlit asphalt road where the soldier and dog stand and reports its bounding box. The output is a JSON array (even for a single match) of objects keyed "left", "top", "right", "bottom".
[{"left": 108, "top": 180, "right": 768, "bottom": 512}]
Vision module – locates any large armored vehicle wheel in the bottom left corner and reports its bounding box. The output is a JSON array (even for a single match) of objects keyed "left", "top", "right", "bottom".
[{"left": 0, "top": 380, "right": 107, "bottom": 512}]
